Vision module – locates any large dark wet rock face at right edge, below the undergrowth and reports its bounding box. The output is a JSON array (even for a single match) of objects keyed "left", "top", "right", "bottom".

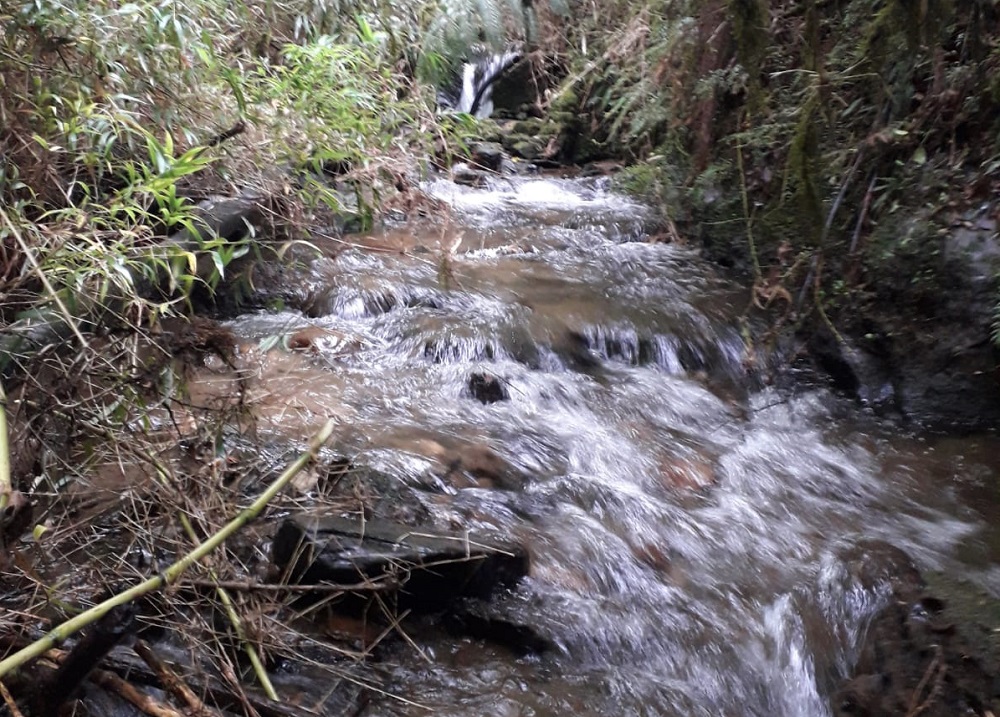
[{"left": 808, "top": 205, "right": 1000, "bottom": 431}]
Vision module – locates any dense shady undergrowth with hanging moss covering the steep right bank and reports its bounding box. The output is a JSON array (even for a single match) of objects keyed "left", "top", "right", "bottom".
[{"left": 561, "top": 0, "right": 1000, "bottom": 336}]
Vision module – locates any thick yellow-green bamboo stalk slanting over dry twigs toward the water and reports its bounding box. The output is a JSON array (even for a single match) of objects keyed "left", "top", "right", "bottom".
[{"left": 0, "top": 419, "right": 335, "bottom": 678}]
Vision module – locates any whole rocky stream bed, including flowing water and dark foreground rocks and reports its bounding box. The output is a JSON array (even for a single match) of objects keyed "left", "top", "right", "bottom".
[{"left": 3, "top": 166, "right": 1000, "bottom": 717}]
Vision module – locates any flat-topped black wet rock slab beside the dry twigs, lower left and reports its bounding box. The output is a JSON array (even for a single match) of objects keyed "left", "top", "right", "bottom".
[{"left": 272, "top": 515, "right": 529, "bottom": 612}]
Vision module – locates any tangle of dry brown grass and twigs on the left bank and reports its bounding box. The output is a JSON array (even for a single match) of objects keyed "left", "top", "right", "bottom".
[{"left": 0, "top": 327, "right": 408, "bottom": 714}]
